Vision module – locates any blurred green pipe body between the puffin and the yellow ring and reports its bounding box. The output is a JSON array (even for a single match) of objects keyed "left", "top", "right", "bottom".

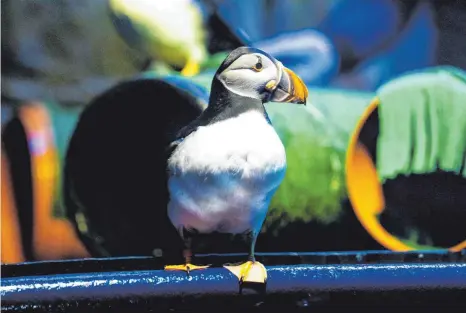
[{"left": 265, "top": 88, "right": 374, "bottom": 224}]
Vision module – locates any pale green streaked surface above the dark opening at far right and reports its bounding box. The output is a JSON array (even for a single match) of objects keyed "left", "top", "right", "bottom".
[{"left": 377, "top": 67, "right": 466, "bottom": 182}]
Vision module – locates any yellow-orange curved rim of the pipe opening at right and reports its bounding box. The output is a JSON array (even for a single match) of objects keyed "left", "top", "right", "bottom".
[{"left": 345, "top": 97, "right": 466, "bottom": 252}]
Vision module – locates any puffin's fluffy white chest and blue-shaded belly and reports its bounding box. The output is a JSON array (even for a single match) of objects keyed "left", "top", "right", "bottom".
[{"left": 168, "top": 112, "right": 286, "bottom": 233}]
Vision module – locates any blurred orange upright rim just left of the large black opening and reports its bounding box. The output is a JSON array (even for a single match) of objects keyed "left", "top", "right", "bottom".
[{"left": 19, "top": 103, "right": 89, "bottom": 260}]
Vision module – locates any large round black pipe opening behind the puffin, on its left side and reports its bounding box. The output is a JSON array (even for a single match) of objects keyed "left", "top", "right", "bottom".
[{"left": 63, "top": 77, "right": 208, "bottom": 256}]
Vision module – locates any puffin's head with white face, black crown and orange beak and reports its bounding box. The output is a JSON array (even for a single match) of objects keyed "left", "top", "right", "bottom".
[{"left": 214, "top": 47, "right": 308, "bottom": 104}]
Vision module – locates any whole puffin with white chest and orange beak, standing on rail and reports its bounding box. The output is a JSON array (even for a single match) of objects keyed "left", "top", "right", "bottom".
[{"left": 164, "top": 47, "right": 308, "bottom": 285}]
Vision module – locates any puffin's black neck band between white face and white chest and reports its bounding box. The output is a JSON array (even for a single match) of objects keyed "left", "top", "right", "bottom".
[{"left": 203, "top": 78, "right": 268, "bottom": 123}]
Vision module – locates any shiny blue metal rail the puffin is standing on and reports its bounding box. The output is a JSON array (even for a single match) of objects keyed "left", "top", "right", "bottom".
[{"left": 0, "top": 251, "right": 466, "bottom": 311}]
